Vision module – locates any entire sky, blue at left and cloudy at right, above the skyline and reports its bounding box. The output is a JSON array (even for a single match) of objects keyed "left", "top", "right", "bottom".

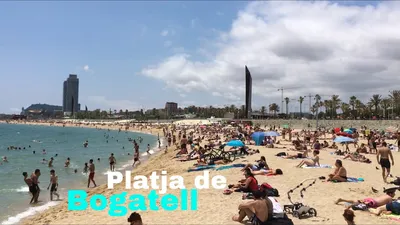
[{"left": 0, "top": 1, "right": 400, "bottom": 113}]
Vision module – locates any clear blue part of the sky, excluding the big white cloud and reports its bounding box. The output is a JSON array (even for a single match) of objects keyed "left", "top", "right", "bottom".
[{"left": 0, "top": 1, "right": 394, "bottom": 113}]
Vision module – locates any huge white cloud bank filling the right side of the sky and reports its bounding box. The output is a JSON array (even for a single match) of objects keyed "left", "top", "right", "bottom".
[{"left": 141, "top": 1, "right": 400, "bottom": 106}]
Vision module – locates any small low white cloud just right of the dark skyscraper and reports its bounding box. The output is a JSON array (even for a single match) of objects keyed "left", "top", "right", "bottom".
[{"left": 87, "top": 96, "right": 141, "bottom": 111}]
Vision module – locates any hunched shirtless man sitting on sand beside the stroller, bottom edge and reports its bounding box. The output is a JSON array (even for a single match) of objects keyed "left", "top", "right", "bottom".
[{"left": 232, "top": 191, "right": 272, "bottom": 225}]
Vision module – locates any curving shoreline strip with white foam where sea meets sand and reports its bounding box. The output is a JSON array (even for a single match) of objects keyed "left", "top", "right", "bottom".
[{"left": 0, "top": 122, "right": 165, "bottom": 224}]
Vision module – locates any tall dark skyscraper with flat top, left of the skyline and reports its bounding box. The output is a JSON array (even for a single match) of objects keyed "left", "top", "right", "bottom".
[{"left": 63, "top": 74, "right": 80, "bottom": 115}]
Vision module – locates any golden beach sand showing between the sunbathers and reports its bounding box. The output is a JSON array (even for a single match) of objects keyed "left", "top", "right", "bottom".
[{"left": 3, "top": 120, "right": 400, "bottom": 224}]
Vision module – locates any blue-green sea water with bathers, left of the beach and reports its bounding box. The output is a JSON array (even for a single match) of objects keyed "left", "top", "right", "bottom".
[{"left": 0, "top": 124, "right": 158, "bottom": 224}]
